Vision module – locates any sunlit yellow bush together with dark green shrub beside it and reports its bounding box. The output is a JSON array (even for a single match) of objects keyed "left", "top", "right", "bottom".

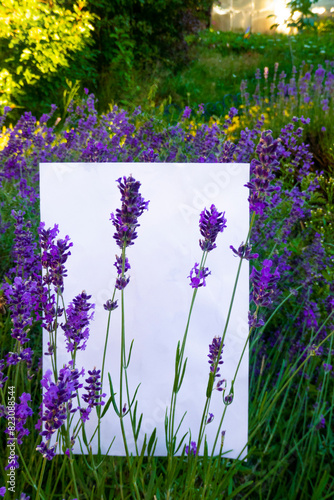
[{"left": 0, "top": 0, "right": 212, "bottom": 115}]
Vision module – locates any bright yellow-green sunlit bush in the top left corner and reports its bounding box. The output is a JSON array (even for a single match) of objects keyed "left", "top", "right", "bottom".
[{"left": 0, "top": 0, "right": 94, "bottom": 107}]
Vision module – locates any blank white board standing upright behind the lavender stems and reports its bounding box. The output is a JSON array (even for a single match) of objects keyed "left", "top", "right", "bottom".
[{"left": 40, "top": 163, "right": 249, "bottom": 458}]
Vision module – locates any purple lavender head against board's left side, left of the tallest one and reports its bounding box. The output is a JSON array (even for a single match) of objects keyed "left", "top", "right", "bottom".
[{"left": 61, "top": 291, "right": 95, "bottom": 352}]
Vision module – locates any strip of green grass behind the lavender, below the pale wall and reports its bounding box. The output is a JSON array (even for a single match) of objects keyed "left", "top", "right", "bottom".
[{"left": 92, "top": 29, "right": 334, "bottom": 116}]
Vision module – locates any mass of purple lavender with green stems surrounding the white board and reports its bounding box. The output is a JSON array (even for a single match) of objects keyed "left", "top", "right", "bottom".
[{"left": 0, "top": 88, "right": 334, "bottom": 499}]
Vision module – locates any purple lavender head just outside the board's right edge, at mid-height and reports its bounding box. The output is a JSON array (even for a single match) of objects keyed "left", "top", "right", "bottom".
[{"left": 250, "top": 259, "right": 280, "bottom": 307}]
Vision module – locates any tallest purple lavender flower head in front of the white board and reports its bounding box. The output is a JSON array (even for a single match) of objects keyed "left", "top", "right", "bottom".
[{"left": 110, "top": 175, "right": 149, "bottom": 249}]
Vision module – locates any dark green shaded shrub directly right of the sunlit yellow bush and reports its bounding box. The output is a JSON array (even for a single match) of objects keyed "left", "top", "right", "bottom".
[{"left": 83, "top": 0, "right": 212, "bottom": 105}]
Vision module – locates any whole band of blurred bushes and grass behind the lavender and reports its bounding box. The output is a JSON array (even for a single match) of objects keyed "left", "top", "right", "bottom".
[{"left": 0, "top": 0, "right": 334, "bottom": 121}]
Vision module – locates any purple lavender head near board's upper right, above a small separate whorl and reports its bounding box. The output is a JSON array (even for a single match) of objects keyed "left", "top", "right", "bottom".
[{"left": 199, "top": 205, "right": 226, "bottom": 252}]
